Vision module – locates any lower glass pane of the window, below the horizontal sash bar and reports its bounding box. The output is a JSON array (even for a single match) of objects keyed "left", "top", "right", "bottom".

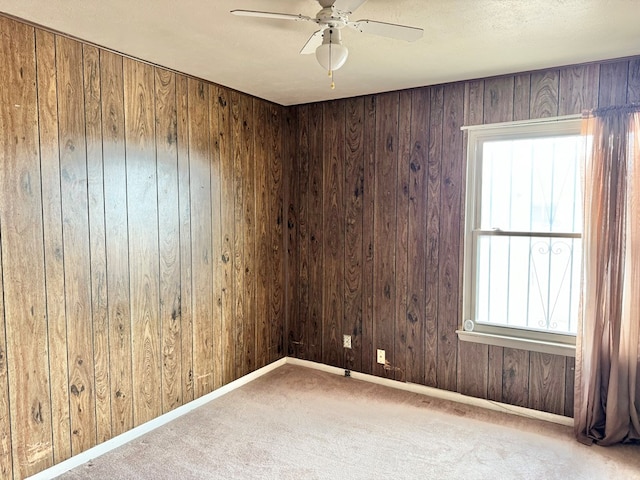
[{"left": 475, "top": 236, "right": 582, "bottom": 334}]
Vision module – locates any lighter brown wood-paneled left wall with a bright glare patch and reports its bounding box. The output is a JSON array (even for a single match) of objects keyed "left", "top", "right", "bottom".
[{"left": 0, "top": 16, "right": 288, "bottom": 479}]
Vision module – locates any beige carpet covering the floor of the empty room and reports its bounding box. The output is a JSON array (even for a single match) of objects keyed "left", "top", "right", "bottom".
[{"left": 60, "top": 365, "right": 640, "bottom": 480}]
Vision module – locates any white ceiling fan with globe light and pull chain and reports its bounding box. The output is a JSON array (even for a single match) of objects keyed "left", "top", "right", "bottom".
[{"left": 231, "top": 0, "right": 424, "bottom": 88}]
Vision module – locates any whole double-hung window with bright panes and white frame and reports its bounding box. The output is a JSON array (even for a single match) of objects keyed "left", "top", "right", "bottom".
[{"left": 461, "top": 119, "right": 584, "bottom": 354}]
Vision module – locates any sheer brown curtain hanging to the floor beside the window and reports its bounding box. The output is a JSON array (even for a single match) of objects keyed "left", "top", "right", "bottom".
[{"left": 574, "top": 106, "right": 640, "bottom": 445}]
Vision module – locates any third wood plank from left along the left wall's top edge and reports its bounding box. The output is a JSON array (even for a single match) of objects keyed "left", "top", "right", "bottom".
[{"left": 56, "top": 37, "right": 96, "bottom": 455}]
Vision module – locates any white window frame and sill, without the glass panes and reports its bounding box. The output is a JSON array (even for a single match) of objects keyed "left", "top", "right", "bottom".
[{"left": 457, "top": 116, "right": 581, "bottom": 356}]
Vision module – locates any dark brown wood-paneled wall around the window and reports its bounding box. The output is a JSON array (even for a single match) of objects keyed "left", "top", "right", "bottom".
[{"left": 287, "top": 58, "right": 640, "bottom": 416}]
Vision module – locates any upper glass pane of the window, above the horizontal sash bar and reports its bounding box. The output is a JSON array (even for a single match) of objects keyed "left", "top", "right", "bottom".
[{"left": 480, "top": 135, "right": 582, "bottom": 232}]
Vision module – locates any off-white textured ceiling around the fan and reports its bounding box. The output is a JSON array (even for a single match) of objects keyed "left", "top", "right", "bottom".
[{"left": 0, "top": 0, "right": 640, "bottom": 105}]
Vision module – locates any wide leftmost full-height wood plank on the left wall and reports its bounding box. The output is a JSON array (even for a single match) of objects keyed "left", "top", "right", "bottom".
[{"left": 0, "top": 17, "right": 53, "bottom": 478}]
